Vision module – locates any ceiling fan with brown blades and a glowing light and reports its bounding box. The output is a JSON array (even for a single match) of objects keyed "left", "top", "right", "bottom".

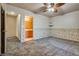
[{"left": 36, "top": 3, "right": 65, "bottom": 12}]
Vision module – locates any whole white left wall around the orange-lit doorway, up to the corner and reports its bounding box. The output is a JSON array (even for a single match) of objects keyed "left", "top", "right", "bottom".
[{"left": 4, "top": 5, "right": 49, "bottom": 42}]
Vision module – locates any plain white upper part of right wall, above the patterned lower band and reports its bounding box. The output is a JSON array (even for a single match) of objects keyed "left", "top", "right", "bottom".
[{"left": 50, "top": 11, "right": 79, "bottom": 29}]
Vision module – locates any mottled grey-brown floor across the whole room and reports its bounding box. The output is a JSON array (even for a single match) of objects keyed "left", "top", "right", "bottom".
[{"left": 0, "top": 37, "right": 79, "bottom": 56}]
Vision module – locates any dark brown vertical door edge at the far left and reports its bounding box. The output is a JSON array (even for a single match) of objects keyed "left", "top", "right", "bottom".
[{"left": 1, "top": 6, "right": 5, "bottom": 54}]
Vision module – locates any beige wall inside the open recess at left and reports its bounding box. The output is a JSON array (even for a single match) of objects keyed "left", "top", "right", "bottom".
[{"left": 5, "top": 13, "right": 18, "bottom": 39}]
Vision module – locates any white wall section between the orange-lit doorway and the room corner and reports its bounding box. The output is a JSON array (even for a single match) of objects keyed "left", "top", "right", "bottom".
[{"left": 34, "top": 14, "right": 49, "bottom": 39}]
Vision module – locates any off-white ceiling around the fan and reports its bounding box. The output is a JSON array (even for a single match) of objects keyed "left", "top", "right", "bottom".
[{"left": 6, "top": 3, "right": 79, "bottom": 17}]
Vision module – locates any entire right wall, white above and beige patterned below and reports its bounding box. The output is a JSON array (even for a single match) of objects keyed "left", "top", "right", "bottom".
[{"left": 50, "top": 11, "right": 79, "bottom": 41}]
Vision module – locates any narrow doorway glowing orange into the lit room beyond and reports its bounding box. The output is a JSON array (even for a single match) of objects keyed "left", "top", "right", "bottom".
[{"left": 24, "top": 16, "right": 33, "bottom": 41}]
